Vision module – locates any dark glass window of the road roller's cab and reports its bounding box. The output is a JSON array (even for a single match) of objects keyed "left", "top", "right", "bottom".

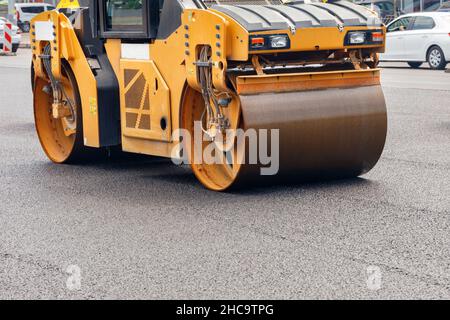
[{"left": 106, "top": 0, "right": 144, "bottom": 31}]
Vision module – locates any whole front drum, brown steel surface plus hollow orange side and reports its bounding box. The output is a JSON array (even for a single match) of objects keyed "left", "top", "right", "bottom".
[{"left": 182, "top": 75, "right": 387, "bottom": 191}]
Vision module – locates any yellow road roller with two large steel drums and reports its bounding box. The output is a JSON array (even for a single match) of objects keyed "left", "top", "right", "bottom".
[{"left": 30, "top": 0, "right": 387, "bottom": 191}]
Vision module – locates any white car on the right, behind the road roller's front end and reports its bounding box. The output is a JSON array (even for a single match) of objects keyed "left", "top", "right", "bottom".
[{"left": 380, "top": 12, "right": 450, "bottom": 70}]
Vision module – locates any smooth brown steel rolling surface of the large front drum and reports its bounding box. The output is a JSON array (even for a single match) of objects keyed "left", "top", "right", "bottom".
[{"left": 236, "top": 85, "right": 387, "bottom": 182}]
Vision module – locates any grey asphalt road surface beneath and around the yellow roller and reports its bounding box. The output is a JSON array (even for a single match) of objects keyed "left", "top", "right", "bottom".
[{"left": 0, "top": 50, "right": 450, "bottom": 299}]
